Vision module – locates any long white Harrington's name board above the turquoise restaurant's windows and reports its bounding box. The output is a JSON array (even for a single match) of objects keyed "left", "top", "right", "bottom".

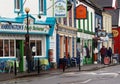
[{"left": 0, "top": 23, "right": 50, "bottom": 33}]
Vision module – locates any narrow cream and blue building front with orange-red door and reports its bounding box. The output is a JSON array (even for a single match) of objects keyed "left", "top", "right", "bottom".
[{"left": 56, "top": 0, "right": 77, "bottom": 67}]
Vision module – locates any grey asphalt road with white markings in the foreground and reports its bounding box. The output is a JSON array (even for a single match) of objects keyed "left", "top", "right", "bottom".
[{"left": 0, "top": 65, "right": 120, "bottom": 84}]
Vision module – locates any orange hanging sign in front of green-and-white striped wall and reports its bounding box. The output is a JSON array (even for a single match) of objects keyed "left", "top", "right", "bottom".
[{"left": 76, "top": 4, "right": 87, "bottom": 19}]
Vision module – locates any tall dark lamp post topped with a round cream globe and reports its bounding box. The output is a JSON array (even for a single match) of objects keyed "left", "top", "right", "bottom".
[{"left": 25, "top": 8, "right": 31, "bottom": 73}]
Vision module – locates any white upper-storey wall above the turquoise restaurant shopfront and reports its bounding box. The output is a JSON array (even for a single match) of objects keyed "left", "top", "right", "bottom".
[{"left": 0, "top": 0, "right": 54, "bottom": 21}]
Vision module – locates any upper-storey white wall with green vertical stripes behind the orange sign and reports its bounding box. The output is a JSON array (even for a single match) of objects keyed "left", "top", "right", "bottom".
[{"left": 76, "top": 2, "right": 95, "bottom": 32}]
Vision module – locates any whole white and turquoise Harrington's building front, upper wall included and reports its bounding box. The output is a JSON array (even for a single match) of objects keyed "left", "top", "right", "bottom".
[{"left": 0, "top": 0, "right": 56, "bottom": 71}]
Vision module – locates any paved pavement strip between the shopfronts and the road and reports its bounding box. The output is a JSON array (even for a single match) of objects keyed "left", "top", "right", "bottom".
[{"left": 0, "top": 64, "right": 117, "bottom": 81}]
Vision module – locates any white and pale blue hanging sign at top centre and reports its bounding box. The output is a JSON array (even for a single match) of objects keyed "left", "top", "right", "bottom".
[{"left": 54, "top": 0, "right": 67, "bottom": 17}]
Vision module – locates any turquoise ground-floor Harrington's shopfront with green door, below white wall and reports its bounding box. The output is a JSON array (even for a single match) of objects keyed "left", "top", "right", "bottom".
[{"left": 0, "top": 15, "right": 55, "bottom": 71}]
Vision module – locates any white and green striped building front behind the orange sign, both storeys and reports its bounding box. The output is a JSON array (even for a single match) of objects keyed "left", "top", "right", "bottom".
[{"left": 76, "top": 2, "right": 95, "bottom": 65}]
